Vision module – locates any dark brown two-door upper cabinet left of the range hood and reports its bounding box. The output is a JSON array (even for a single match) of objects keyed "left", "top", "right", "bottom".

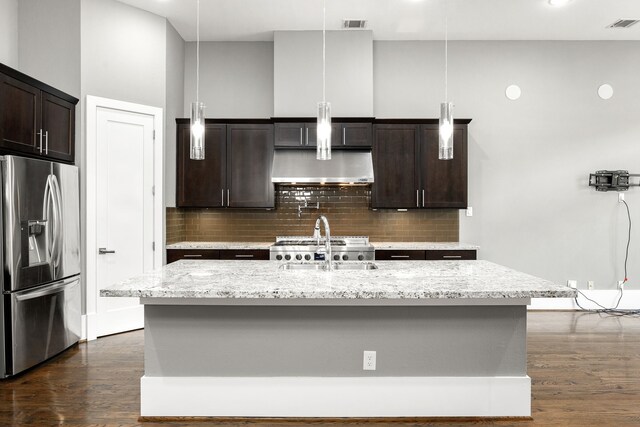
[{"left": 176, "top": 119, "right": 275, "bottom": 208}]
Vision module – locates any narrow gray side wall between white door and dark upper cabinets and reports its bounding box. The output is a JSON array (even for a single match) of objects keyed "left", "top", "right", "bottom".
[{"left": 164, "top": 21, "right": 185, "bottom": 206}]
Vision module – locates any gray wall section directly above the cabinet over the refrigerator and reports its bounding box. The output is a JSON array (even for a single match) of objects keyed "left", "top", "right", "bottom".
[{"left": 18, "top": 0, "right": 80, "bottom": 98}]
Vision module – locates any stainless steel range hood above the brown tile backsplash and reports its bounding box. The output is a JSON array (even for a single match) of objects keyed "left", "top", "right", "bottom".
[{"left": 271, "top": 150, "right": 373, "bottom": 184}]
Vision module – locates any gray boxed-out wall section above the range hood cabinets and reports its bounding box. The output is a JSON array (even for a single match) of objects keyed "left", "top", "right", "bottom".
[{"left": 273, "top": 31, "right": 373, "bottom": 117}]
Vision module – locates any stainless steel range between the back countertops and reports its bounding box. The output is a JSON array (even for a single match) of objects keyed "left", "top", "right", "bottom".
[{"left": 269, "top": 236, "right": 375, "bottom": 261}]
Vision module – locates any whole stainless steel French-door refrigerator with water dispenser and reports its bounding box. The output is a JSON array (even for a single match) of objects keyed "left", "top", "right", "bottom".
[{"left": 0, "top": 156, "right": 82, "bottom": 378}]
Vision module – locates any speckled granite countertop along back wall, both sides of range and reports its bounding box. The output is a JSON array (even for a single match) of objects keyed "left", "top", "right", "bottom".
[{"left": 167, "top": 240, "right": 480, "bottom": 250}]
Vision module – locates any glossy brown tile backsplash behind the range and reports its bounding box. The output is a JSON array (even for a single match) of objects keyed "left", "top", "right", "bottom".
[{"left": 162, "top": 186, "right": 459, "bottom": 244}]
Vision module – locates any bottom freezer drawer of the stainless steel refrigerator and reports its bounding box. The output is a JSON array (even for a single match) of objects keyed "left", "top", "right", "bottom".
[{"left": 4, "top": 276, "right": 81, "bottom": 375}]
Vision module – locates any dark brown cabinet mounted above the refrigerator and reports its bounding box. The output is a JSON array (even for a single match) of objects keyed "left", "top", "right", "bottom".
[{"left": 0, "top": 64, "right": 78, "bottom": 163}]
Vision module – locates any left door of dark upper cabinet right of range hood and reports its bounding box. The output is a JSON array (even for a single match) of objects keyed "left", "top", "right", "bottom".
[{"left": 371, "top": 124, "right": 420, "bottom": 209}]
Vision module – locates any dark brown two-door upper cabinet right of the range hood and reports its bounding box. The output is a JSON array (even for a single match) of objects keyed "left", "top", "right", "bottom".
[{"left": 371, "top": 119, "right": 469, "bottom": 209}]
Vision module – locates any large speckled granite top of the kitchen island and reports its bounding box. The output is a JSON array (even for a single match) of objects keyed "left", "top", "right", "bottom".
[{"left": 100, "top": 260, "right": 575, "bottom": 300}]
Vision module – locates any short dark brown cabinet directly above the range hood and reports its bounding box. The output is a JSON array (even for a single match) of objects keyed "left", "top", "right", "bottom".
[{"left": 274, "top": 119, "right": 372, "bottom": 149}]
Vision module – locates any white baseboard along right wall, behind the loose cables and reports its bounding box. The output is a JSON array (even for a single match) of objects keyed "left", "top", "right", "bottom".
[{"left": 529, "top": 289, "right": 640, "bottom": 310}]
